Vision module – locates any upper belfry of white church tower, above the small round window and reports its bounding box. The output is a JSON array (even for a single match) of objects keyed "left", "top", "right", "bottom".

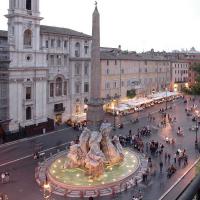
[{"left": 6, "top": 0, "right": 42, "bottom": 51}]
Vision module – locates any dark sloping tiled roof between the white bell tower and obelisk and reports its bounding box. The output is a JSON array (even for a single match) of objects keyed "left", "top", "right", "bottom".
[{"left": 40, "top": 25, "right": 91, "bottom": 38}]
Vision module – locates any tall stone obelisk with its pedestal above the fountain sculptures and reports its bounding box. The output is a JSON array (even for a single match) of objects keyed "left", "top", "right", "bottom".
[{"left": 87, "top": 2, "right": 104, "bottom": 130}]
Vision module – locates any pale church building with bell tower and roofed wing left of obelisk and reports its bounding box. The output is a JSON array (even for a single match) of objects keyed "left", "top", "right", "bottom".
[{"left": 1, "top": 0, "right": 91, "bottom": 131}]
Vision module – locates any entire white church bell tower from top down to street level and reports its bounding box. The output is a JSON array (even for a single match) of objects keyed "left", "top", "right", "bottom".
[{"left": 6, "top": 0, "right": 47, "bottom": 131}]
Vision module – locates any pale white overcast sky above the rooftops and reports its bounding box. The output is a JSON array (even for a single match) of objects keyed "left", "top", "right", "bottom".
[{"left": 0, "top": 0, "right": 200, "bottom": 52}]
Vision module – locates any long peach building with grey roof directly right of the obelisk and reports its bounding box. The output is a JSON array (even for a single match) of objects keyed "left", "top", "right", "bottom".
[{"left": 101, "top": 48, "right": 171, "bottom": 99}]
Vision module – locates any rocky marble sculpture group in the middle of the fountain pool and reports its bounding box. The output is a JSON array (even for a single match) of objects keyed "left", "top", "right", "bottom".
[{"left": 64, "top": 123, "right": 124, "bottom": 178}]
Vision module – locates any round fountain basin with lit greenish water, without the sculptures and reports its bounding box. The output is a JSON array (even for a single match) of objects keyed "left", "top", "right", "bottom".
[{"left": 36, "top": 149, "right": 147, "bottom": 197}]
